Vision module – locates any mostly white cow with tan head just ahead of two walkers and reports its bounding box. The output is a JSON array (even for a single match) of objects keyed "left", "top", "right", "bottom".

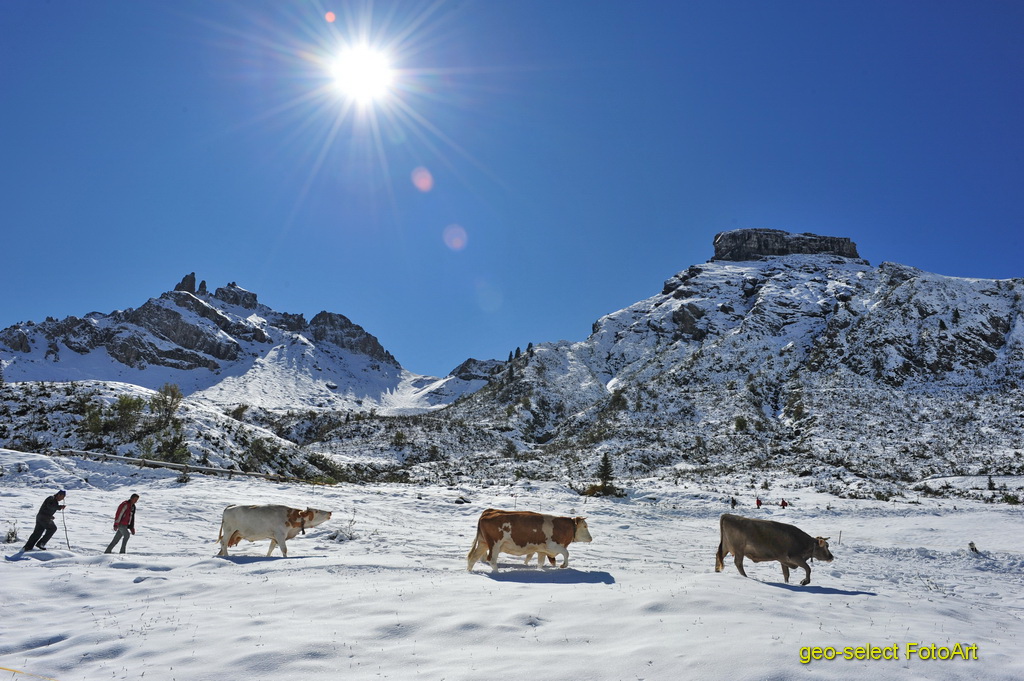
[{"left": 217, "top": 504, "right": 331, "bottom": 557}]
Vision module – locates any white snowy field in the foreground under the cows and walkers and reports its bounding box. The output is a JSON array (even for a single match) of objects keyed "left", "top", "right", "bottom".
[{"left": 0, "top": 451, "right": 1024, "bottom": 681}]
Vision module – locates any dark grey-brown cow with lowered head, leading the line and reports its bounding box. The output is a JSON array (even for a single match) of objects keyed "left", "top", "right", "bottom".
[{"left": 715, "top": 513, "right": 833, "bottom": 586}]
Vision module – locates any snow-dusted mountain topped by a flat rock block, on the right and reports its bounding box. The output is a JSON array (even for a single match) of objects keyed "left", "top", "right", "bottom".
[{"left": 417, "top": 230, "right": 1024, "bottom": 486}]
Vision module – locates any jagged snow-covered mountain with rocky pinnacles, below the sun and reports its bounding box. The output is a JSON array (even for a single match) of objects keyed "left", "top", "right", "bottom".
[{"left": 0, "top": 273, "right": 485, "bottom": 414}]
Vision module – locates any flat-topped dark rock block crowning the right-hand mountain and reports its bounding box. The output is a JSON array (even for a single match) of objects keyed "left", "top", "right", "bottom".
[{"left": 712, "top": 229, "right": 866, "bottom": 264}]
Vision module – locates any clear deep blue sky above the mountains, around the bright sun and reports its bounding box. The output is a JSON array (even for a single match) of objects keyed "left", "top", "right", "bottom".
[{"left": 0, "top": 0, "right": 1024, "bottom": 375}]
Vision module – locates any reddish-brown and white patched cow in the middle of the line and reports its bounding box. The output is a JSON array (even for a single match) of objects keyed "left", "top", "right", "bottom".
[{"left": 466, "top": 508, "right": 593, "bottom": 571}]
